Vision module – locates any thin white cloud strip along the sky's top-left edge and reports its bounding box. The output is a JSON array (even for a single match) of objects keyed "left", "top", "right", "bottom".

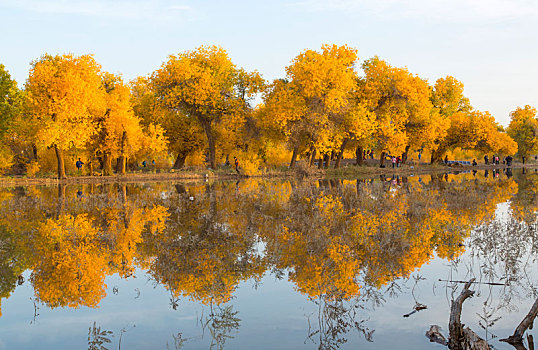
[{"left": 0, "top": 0, "right": 192, "bottom": 19}]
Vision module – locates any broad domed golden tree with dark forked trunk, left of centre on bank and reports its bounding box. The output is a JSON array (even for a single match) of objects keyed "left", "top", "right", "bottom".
[{"left": 152, "top": 46, "right": 263, "bottom": 168}]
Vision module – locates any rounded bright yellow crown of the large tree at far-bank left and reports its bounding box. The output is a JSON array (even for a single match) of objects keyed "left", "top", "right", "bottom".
[{"left": 26, "top": 55, "right": 104, "bottom": 150}]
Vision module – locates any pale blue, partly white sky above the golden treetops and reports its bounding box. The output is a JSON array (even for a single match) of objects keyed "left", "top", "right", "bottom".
[{"left": 0, "top": 0, "right": 538, "bottom": 126}]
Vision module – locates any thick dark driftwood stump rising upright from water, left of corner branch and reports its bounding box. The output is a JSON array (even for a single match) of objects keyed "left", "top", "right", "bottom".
[{"left": 448, "top": 278, "right": 489, "bottom": 350}]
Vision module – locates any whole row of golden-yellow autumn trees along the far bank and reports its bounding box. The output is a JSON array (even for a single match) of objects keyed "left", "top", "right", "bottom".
[{"left": 0, "top": 45, "right": 538, "bottom": 178}]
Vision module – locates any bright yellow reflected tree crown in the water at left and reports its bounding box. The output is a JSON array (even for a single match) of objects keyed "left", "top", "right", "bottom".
[{"left": 32, "top": 214, "right": 107, "bottom": 308}]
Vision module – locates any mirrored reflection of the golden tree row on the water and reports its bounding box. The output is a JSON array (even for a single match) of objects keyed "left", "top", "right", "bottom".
[{"left": 0, "top": 171, "right": 538, "bottom": 349}]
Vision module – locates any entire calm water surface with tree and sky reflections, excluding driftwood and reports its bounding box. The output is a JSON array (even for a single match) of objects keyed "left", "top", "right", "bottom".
[{"left": 0, "top": 169, "right": 538, "bottom": 349}]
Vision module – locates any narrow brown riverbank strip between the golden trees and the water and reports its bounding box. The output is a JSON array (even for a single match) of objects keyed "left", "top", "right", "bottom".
[{"left": 0, "top": 161, "right": 538, "bottom": 187}]
